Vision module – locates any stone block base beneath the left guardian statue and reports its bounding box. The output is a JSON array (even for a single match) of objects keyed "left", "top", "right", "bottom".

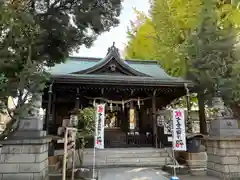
[{"left": 0, "top": 139, "right": 48, "bottom": 180}]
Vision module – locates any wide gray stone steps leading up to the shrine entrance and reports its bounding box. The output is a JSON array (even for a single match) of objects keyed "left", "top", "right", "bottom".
[{"left": 83, "top": 148, "right": 171, "bottom": 167}]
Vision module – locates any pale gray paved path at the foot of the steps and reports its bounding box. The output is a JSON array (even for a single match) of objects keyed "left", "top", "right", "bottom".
[{"left": 100, "top": 168, "right": 168, "bottom": 180}]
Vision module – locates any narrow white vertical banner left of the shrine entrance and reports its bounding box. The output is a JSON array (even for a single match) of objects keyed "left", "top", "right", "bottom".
[{"left": 94, "top": 104, "right": 105, "bottom": 149}]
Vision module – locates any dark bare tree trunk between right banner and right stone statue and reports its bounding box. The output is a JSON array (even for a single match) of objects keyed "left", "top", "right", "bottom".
[{"left": 197, "top": 93, "right": 207, "bottom": 134}]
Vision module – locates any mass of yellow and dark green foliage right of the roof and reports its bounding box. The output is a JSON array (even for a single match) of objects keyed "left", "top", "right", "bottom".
[{"left": 126, "top": 0, "right": 240, "bottom": 109}]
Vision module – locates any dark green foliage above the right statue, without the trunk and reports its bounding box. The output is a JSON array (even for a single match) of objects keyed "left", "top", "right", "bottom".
[{"left": 183, "top": 0, "right": 240, "bottom": 110}]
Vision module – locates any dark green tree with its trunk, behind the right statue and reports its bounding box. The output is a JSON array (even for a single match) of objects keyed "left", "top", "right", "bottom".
[{"left": 184, "top": 0, "right": 239, "bottom": 134}]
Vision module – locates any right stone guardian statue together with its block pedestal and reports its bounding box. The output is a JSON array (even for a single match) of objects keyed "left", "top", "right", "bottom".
[{"left": 206, "top": 97, "right": 240, "bottom": 180}]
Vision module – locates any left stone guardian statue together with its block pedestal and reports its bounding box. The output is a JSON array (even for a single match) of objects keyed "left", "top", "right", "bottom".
[{"left": 0, "top": 94, "right": 49, "bottom": 180}]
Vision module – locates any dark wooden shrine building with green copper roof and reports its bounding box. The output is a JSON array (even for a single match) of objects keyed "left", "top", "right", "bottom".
[{"left": 43, "top": 46, "right": 193, "bottom": 148}]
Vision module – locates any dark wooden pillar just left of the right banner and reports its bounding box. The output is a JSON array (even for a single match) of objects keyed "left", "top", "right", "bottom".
[{"left": 152, "top": 90, "right": 158, "bottom": 148}]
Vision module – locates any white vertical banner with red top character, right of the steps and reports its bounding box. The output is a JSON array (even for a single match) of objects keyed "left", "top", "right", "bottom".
[{"left": 172, "top": 109, "right": 187, "bottom": 151}]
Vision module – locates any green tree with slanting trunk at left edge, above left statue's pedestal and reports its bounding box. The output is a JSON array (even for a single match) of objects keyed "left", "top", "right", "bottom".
[{"left": 0, "top": 4, "right": 47, "bottom": 139}]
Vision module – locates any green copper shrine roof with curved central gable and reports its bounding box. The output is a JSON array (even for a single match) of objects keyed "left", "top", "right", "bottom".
[{"left": 49, "top": 46, "right": 193, "bottom": 84}]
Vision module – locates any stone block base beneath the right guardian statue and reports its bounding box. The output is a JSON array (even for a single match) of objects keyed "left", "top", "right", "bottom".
[{"left": 207, "top": 137, "right": 240, "bottom": 180}]
